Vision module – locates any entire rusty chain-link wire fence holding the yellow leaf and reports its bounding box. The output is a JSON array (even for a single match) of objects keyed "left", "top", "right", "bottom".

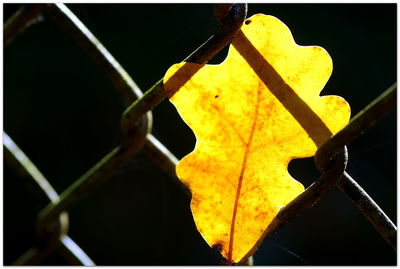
[{"left": 3, "top": 4, "right": 397, "bottom": 265}]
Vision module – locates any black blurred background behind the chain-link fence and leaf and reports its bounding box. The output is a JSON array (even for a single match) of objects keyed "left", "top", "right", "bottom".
[{"left": 3, "top": 4, "right": 397, "bottom": 265}]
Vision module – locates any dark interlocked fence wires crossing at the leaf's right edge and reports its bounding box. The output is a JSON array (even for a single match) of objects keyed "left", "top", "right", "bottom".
[{"left": 266, "top": 83, "right": 397, "bottom": 250}]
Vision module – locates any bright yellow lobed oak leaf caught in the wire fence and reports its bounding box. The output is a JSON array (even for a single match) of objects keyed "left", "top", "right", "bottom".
[{"left": 164, "top": 14, "right": 350, "bottom": 263}]
